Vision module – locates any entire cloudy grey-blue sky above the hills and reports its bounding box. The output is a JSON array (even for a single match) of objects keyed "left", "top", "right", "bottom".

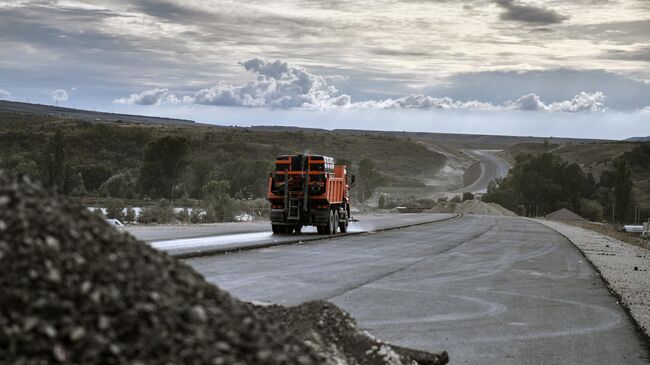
[{"left": 0, "top": 0, "right": 650, "bottom": 139}]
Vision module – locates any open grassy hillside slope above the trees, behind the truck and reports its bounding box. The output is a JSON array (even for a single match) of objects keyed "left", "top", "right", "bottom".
[{"left": 0, "top": 111, "right": 446, "bottom": 199}]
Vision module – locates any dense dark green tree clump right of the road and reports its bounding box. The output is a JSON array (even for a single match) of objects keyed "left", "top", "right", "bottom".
[{"left": 483, "top": 143, "right": 650, "bottom": 223}]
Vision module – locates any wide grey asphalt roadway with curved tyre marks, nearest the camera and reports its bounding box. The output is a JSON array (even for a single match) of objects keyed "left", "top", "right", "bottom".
[{"left": 186, "top": 216, "right": 649, "bottom": 364}]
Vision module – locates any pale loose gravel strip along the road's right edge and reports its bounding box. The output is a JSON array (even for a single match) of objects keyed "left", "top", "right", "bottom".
[{"left": 534, "top": 219, "right": 650, "bottom": 340}]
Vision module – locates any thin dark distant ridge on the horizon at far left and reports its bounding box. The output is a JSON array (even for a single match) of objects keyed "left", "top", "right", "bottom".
[{"left": 0, "top": 100, "right": 194, "bottom": 124}]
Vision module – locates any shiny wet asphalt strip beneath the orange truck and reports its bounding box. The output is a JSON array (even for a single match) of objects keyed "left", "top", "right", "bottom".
[{"left": 134, "top": 213, "right": 455, "bottom": 256}]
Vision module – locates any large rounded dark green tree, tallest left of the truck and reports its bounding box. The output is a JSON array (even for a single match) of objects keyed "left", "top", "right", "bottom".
[{"left": 140, "top": 136, "right": 190, "bottom": 199}]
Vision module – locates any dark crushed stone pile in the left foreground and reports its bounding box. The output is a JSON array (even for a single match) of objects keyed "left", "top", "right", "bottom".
[{"left": 0, "top": 171, "right": 448, "bottom": 365}]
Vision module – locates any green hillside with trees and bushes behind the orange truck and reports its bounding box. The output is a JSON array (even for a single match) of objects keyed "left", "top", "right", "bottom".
[{"left": 0, "top": 113, "right": 445, "bottom": 223}]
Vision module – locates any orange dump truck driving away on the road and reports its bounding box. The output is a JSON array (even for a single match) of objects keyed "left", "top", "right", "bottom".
[{"left": 268, "top": 155, "right": 354, "bottom": 234}]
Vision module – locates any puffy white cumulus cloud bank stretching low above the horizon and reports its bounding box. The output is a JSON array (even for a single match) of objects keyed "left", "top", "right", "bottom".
[{"left": 113, "top": 58, "right": 605, "bottom": 113}]
